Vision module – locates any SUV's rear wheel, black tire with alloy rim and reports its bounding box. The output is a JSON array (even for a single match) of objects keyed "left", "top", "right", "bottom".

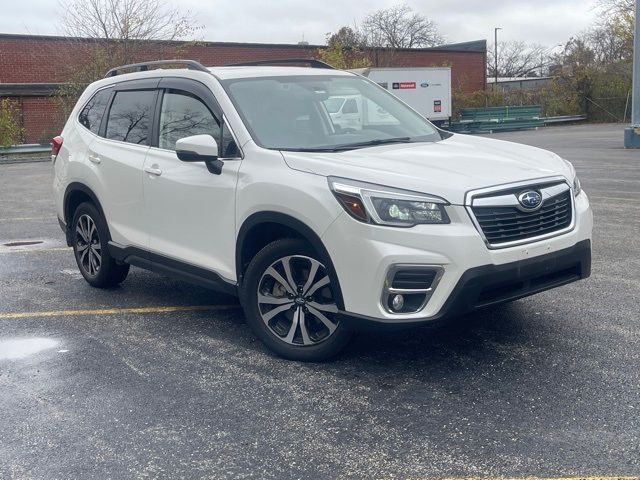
[{"left": 72, "top": 202, "right": 129, "bottom": 288}]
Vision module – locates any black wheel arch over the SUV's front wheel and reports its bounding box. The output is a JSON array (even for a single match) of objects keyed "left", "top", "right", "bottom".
[{"left": 236, "top": 212, "right": 344, "bottom": 310}]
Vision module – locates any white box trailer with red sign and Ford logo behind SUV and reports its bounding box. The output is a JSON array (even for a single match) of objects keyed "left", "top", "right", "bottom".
[{"left": 351, "top": 67, "right": 451, "bottom": 125}]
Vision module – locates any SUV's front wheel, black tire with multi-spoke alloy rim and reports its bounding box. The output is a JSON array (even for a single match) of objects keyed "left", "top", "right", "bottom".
[{"left": 241, "top": 238, "right": 352, "bottom": 362}]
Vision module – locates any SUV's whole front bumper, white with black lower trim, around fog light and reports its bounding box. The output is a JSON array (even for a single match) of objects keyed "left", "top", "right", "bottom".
[{"left": 322, "top": 192, "right": 593, "bottom": 324}]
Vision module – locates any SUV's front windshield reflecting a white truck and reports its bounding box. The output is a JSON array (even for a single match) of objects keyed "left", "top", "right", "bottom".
[{"left": 222, "top": 75, "right": 443, "bottom": 151}]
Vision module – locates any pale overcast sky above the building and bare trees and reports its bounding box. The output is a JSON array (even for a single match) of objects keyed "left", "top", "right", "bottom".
[{"left": 0, "top": 0, "right": 596, "bottom": 46}]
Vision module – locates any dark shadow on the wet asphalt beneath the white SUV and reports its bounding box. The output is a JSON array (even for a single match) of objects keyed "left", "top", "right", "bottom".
[{"left": 117, "top": 272, "right": 553, "bottom": 379}]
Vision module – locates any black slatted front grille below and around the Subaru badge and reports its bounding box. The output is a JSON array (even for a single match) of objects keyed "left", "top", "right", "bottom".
[{"left": 472, "top": 190, "right": 573, "bottom": 245}]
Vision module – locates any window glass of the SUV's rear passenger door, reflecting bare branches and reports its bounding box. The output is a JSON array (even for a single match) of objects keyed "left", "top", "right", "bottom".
[{"left": 106, "top": 90, "right": 156, "bottom": 145}]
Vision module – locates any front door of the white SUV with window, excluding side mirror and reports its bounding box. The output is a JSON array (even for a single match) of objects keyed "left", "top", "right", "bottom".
[{"left": 143, "top": 78, "right": 240, "bottom": 280}]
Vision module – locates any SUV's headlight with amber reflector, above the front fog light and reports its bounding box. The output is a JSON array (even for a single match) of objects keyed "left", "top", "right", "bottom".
[{"left": 329, "top": 177, "right": 451, "bottom": 227}]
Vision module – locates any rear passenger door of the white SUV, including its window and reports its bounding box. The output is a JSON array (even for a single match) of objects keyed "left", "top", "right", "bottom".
[{"left": 88, "top": 79, "right": 159, "bottom": 248}]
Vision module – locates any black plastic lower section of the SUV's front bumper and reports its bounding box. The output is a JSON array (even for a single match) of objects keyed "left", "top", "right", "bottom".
[{"left": 338, "top": 240, "right": 591, "bottom": 329}]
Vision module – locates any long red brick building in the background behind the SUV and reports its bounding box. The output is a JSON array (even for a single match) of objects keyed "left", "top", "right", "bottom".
[{"left": 0, "top": 34, "right": 486, "bottom": 143}]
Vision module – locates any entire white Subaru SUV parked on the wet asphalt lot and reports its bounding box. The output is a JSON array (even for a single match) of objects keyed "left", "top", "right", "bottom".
[{"left": 52, "top": 61, "right": 592, "bottom": 360}]
